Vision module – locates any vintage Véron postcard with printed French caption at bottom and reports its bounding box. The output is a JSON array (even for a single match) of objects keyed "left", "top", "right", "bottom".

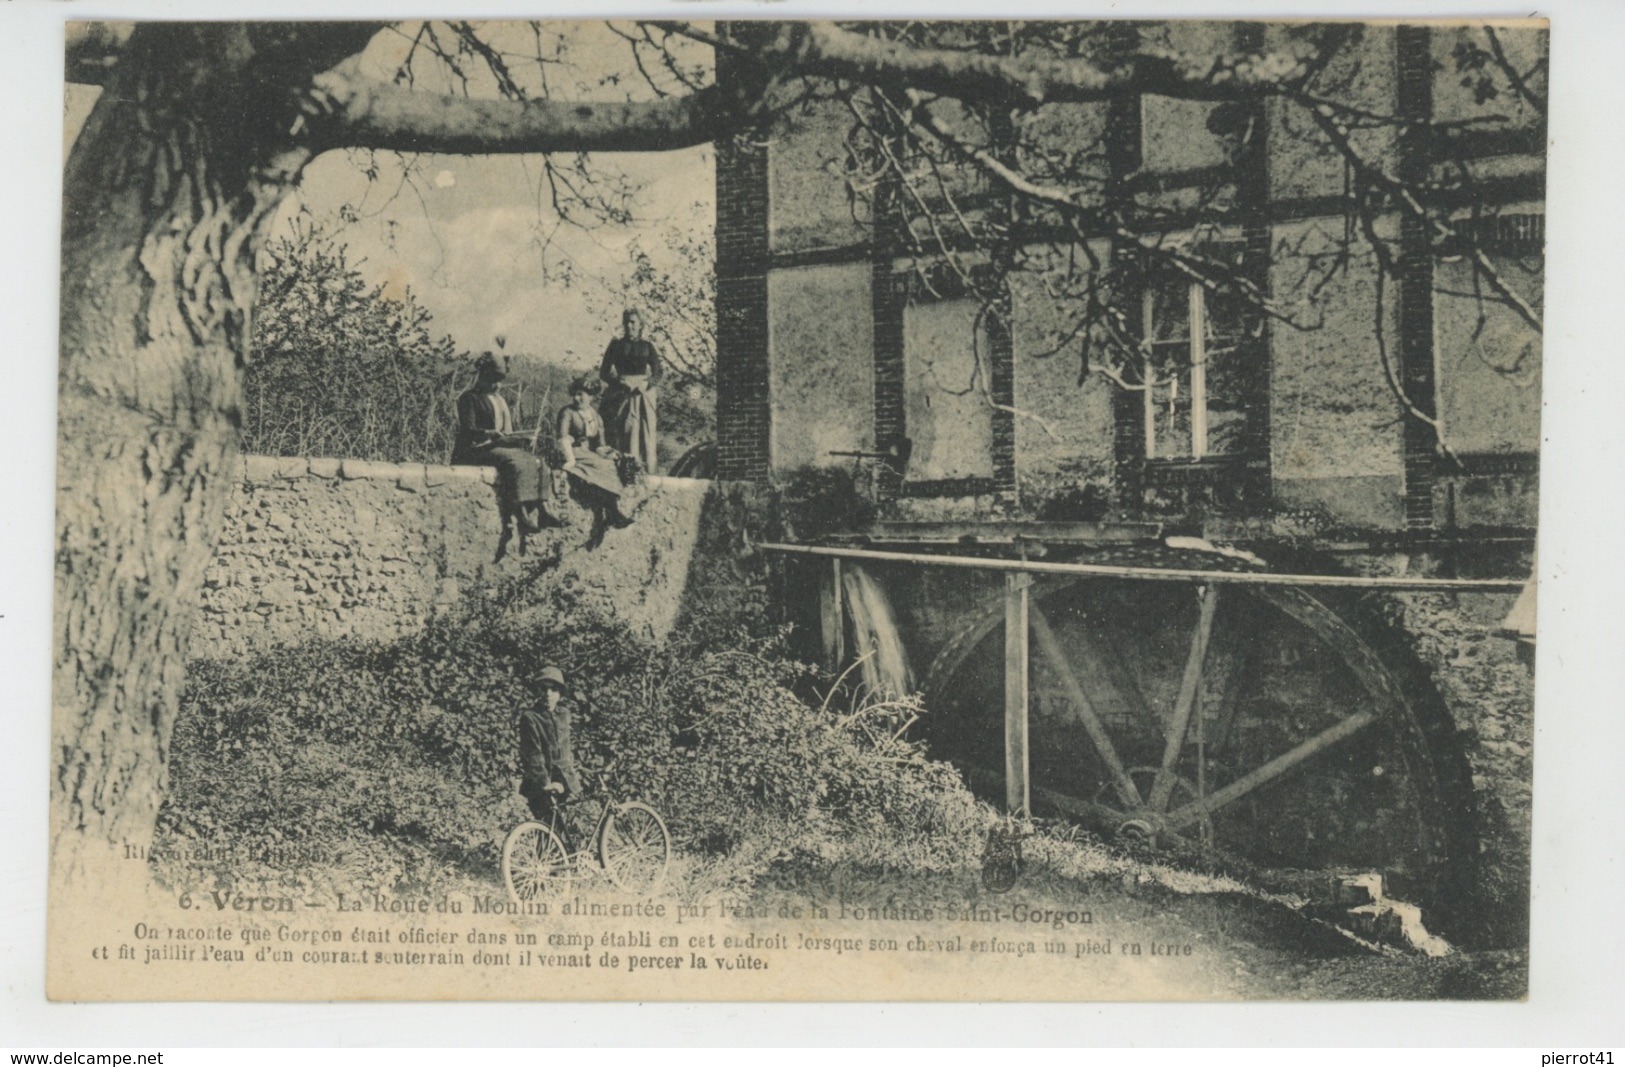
[{"left": 47, "top": 19, "right": 1549, "bottom": 1000}]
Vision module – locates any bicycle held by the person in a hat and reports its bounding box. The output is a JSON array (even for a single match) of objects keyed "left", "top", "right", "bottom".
[{"left": 502, "top": 771, "right": 671, "bottom": 905}]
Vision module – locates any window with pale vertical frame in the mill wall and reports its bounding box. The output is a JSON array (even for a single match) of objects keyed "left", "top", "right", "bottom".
[{"left": 1141, "top": 278, "right": 1258, "bottom": 460}]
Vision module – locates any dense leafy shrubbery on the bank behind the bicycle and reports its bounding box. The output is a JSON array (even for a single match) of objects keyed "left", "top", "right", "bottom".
[{"left": 159, "top": 580, "right": 982, "bottom": 892}]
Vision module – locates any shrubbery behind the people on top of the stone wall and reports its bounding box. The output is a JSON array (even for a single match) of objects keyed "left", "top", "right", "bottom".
[{"left": 244, "top": 216, "right": 715, "bottom": 463}]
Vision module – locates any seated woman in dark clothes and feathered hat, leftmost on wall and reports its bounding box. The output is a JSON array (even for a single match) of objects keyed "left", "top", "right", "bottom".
[{"left": 452, "top": 352, "right": 559, "bottom": 544}]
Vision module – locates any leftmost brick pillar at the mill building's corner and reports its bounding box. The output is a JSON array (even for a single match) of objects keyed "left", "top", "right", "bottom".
[{"left": 717, "top": 31, "right": 772, "bottom": 481}]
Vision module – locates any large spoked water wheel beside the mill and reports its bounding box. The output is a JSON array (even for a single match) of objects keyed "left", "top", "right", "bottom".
[{"left": 926, "top": 578, "right": 1476, "bottom": 921}]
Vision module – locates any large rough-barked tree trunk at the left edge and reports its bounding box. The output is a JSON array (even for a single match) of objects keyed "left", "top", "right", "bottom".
[{"left": 52, "top": 24, "right": 371, "bottom": 880}]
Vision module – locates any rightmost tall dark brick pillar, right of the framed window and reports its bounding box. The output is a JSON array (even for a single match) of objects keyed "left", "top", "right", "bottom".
[{"left": 1394, "top": 26, "right": 1438, "bottom": 531}]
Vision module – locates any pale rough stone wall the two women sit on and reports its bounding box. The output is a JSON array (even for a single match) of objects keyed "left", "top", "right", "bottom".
[{"left": 192, "top": 456, "right": 709, "bottom": 656}]
